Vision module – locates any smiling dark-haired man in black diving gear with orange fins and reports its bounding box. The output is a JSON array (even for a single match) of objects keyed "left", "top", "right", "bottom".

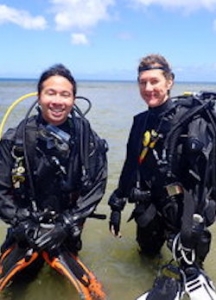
[{"left": 0, "top": 64, "right": 107, "bottom": 300}]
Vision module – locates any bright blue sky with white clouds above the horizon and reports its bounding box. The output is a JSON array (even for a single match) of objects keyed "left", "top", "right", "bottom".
[{"left": 0, "top": 0, "right": 216, "bottom": 82}]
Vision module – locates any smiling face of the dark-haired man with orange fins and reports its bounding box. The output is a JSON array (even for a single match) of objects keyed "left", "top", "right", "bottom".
[{"left": 38, "top": 75, "right": 75, "bottom": 126}]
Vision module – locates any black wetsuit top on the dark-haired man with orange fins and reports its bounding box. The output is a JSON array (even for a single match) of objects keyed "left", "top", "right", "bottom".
[{"left": 0, "top": 114, "right": 107, "bottom": 251}]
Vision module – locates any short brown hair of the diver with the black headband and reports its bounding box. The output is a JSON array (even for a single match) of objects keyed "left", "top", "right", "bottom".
[{"left": 138, "top": 54, "right": 175, "bottom": 80}]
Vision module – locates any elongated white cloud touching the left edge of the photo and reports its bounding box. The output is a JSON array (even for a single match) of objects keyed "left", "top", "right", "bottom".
[{"left": 0, "top": 5, "right": 47, "bottom": 29}]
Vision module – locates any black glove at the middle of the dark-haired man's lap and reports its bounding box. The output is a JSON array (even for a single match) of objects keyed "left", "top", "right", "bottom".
[{"left": 35, "top": 223, "right": 67, "bottom": 250}]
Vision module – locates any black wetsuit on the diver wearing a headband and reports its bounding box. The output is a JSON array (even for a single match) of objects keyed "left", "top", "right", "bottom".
[{"left": 117, "top": 99, "right": 215, "bottom": 254}]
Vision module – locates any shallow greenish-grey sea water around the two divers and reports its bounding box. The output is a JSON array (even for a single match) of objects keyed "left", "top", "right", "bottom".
[{"left": 0, "top": 79, "right": 216, "bottom": 300}]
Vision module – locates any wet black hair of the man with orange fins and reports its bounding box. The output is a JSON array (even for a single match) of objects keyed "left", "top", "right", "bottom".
[{"left": 37, "top": 64, "right": 77, "bottom": 96}]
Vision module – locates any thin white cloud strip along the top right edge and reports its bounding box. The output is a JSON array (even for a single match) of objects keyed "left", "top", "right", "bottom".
[{"left": 128, "top": 0, "right": 216, "bottom": 12}]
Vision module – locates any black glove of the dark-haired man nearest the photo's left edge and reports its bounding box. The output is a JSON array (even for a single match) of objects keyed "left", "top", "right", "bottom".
[{"left": 12, "top": 219, "right": 39, "bottom": 248}]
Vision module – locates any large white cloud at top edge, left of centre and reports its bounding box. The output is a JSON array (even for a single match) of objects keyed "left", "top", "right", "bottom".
[{"left": 50, "top": 0, "right": 115, "bottom": 30}]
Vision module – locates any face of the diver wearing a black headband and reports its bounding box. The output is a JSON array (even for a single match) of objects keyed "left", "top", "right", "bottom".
[{"left": 139, "top": 69, "right": 173, "bottom": 107}]
